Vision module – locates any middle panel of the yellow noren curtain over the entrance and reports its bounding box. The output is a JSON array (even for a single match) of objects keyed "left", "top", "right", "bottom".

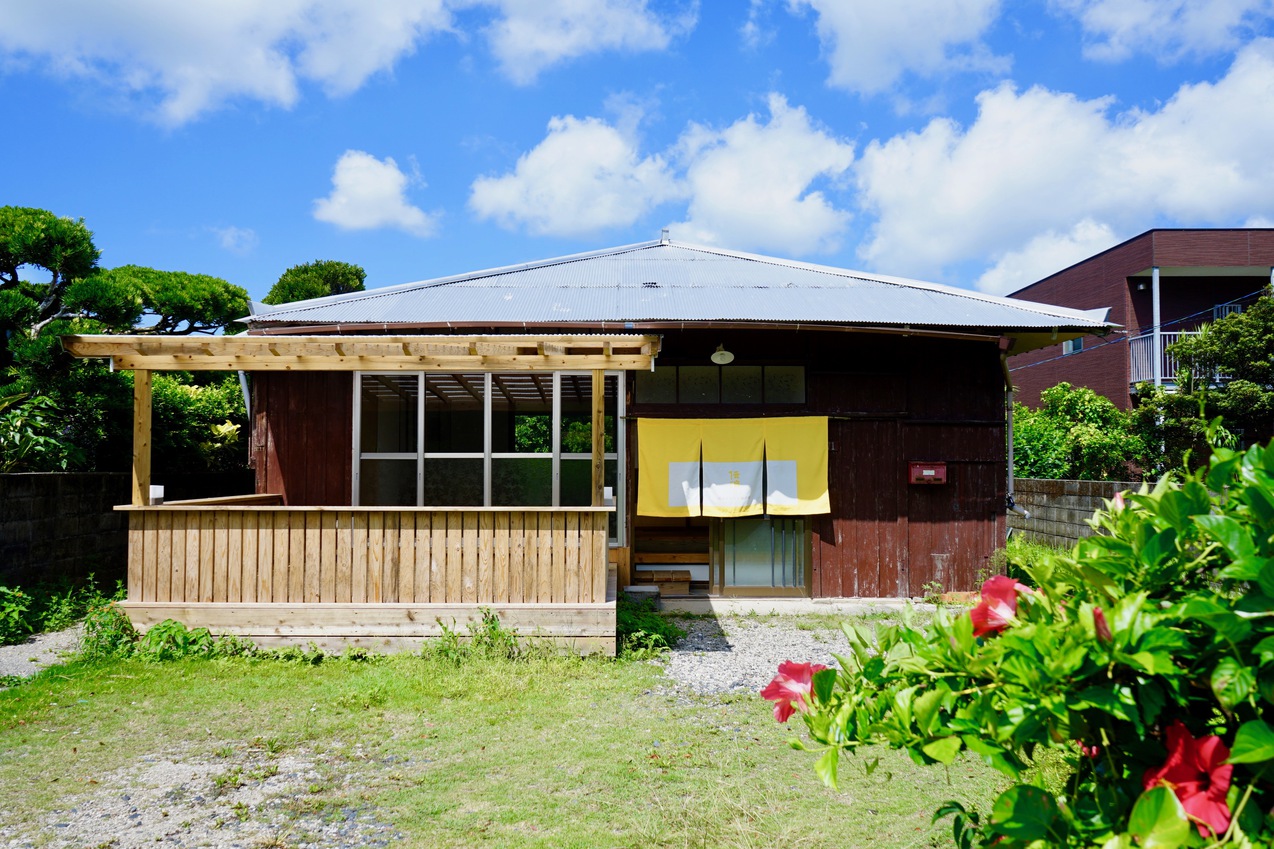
[{"left": 703, "top": 418, "right": 766, "bottom": 519}]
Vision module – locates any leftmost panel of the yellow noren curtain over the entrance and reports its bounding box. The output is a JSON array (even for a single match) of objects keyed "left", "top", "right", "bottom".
[{"left": 637, "top": 418, "right": 702, "bottom": 516}]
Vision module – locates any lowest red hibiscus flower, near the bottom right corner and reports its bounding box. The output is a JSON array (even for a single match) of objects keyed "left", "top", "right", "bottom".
[{"left": 1142, "top": 719, "right": 1235, "bottom": 838}]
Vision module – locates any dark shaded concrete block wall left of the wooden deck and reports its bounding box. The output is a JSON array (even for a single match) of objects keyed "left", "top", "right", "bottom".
[{"left": 0, "top": 472, "right": 131, "bottom": 586}]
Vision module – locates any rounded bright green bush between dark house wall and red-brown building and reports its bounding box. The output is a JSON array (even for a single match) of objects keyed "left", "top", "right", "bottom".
[{"left": 1013, "top": 382, "right": 1142, "bottom": 481}]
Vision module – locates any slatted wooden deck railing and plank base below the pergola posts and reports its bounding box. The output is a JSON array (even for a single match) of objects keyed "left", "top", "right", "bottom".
[{"left": 118, "top": 496, "right": 615, "bottom": 654}]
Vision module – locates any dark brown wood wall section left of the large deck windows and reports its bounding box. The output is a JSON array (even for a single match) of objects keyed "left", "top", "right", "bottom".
[{"left": 251, "top": 371, "right": 354, "bottom": 506}]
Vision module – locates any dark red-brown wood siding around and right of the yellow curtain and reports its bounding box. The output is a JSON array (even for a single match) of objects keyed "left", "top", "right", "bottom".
[{"left": 629, "top": 331, "right": 1006, "bottom": 598}]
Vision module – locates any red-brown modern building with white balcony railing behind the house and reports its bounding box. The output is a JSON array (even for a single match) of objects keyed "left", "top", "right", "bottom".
[{"left": 1009, "top": 228, "right": 1274, "bottom": 409}]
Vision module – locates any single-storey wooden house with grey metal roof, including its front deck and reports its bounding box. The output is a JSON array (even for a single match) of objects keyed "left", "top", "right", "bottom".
[{"left": 64, "top": 238, "right": 1108, "bottom": 650}]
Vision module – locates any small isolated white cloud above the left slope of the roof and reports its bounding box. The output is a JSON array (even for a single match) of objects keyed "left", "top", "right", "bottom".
[{"left": 313, "top": 150, "right": 438, "bottom": 237}]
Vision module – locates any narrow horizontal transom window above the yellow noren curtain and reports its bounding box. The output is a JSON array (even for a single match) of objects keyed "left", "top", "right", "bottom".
[{"left": 636, "top": 366, "right": 805, "bottom": 404}]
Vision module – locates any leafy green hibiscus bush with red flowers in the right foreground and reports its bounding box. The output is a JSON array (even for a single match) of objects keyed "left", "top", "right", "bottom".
[{"left": 763, "top": 433, "right": 1274, "bottom": 849}]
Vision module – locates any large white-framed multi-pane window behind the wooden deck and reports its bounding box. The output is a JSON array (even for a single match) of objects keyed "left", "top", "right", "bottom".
[{"left": 353, "top": 371, "right": 624, "bottom": 543}]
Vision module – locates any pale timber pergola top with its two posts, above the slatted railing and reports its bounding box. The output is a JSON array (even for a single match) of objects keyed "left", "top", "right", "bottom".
[{"left": 62, "top": 334, "right": 659, "bottom": 506}]
